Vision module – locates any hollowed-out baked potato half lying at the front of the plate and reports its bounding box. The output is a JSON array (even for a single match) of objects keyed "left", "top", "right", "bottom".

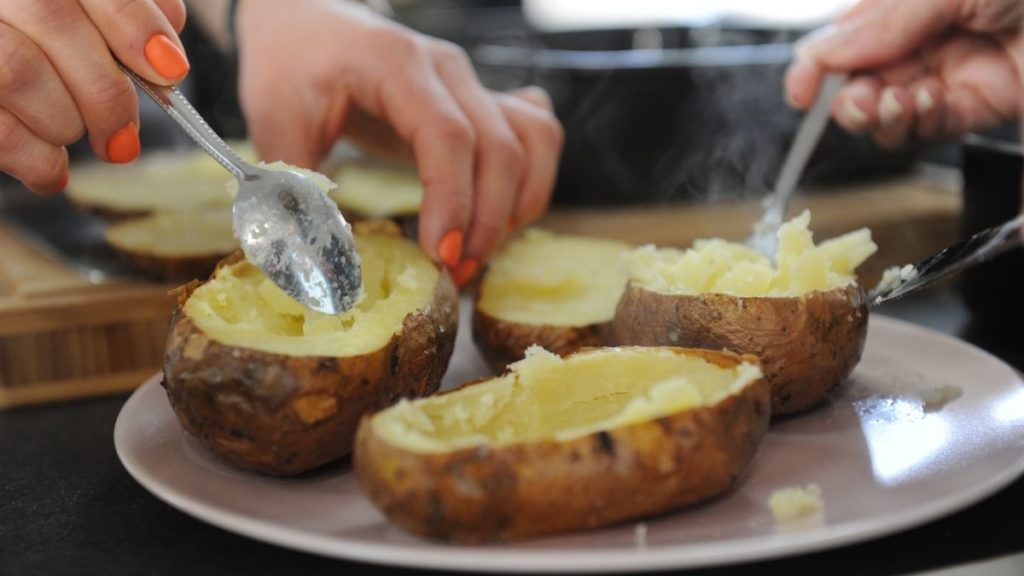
[{"left": 353, "top": 346, "right": 770, "bottom": 543}]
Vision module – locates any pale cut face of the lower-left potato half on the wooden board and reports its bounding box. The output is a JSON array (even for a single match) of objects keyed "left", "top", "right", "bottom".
[{"left": 106, "top": 204, "right": 239, "bottom": 252}]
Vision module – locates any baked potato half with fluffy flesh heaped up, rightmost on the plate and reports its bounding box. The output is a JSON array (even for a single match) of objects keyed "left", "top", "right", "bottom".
[{"left": 611, "top": 208, "right": 877, "bottom": 416}]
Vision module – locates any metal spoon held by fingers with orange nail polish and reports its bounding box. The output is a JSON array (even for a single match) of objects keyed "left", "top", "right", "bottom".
[{"left": 121, "top": 66, "right": 362, "bottom": 314}]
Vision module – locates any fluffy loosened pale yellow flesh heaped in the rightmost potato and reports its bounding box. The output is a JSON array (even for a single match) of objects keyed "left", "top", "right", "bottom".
[{"left": 625, "top": 210, "right": 878, "bottom": 296}]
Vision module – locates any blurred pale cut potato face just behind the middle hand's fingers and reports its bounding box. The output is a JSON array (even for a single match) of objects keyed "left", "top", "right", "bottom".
[{"left": 331, "top": 163, "right": 423, "bottom": 218}]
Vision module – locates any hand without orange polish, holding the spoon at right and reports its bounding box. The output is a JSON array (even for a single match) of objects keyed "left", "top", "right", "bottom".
[{"left": 785, "top": 0, "right": 1024, "bottom": 148}]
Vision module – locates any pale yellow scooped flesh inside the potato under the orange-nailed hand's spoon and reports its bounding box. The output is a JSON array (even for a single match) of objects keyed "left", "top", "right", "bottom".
[{"left": 184, "top": 233, "right": 439, "bottom": 358}]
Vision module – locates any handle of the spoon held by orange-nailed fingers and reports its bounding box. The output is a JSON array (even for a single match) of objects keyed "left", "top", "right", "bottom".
[{"left": 119, "top": 63, "right": 254, "bottom": 180}]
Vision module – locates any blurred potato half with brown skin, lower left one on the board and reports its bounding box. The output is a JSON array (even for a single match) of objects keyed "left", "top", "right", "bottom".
[{"left": 104, "top": 208, "right": 239, "bottom": 280}]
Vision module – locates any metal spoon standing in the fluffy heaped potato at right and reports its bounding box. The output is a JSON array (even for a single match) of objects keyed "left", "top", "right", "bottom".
[{"left": 746, "top": 74, "right": 846, "bottom": 256}]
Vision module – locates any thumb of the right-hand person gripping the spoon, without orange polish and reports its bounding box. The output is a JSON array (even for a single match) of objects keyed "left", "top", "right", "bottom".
[{"left": 795, "top": 0, "right": 956, "bottom": 72}]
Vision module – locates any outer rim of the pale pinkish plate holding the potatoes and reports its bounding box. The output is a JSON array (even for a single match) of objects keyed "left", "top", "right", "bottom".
[{"left": 114, "top": 316, "right": 1024, "bottom": 573}]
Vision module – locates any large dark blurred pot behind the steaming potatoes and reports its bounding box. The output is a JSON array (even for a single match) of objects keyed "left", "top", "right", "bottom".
[{"left": 470, "top": 28, "right": 913, "bottom": 204}]
